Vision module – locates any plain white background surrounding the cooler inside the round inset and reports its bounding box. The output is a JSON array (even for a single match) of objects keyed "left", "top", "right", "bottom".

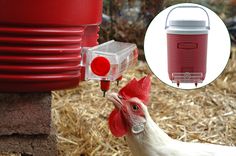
[{"left": 144, "top": 3, "right": 231, "bottom": 89}]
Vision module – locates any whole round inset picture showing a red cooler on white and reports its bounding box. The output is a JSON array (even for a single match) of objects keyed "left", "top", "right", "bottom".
[{"left": 144, "top": 3, "right": 231, "bottom": 89}]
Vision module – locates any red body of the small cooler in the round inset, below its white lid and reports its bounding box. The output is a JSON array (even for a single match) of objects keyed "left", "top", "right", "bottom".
[{"left": 167, "top": 34, "right": 208, "bottom": 83}]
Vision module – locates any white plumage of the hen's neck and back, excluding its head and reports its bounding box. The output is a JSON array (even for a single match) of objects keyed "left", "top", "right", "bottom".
[{"left": 127, "top": 103, "right": 236, "bottom": 156}]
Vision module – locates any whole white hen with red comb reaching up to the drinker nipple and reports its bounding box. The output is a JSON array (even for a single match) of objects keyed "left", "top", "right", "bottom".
[{"left": 108, "top": 77, "right": 236, "bottom": 156}]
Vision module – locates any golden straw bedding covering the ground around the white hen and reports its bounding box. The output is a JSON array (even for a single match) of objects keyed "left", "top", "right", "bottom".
[{"left": 52, "top": 58, "right": 236, "bottom": 156}]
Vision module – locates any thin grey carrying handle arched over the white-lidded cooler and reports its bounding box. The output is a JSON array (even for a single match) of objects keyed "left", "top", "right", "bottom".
[{"left": 165, "top": 5, "right": 210, "bottom": 30}]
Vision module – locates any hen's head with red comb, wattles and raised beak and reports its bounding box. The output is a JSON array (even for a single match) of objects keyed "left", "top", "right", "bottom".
[{"left": 108, "top": 76, "right": 151, "bottom": 137}]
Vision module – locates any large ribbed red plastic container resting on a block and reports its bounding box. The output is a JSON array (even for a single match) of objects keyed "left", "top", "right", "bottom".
[{"left": 0, "top": 0, "right": 102, "bottom": 92}]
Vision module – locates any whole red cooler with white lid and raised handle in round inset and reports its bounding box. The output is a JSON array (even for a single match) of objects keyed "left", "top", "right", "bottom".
[{"left": 165, "top": 5, "right": 210, "bottom": 86}]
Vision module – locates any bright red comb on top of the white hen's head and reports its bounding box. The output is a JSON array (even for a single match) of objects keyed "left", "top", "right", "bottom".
[{"left": 119, "top": 75, "right": 151, "bottom": 104}]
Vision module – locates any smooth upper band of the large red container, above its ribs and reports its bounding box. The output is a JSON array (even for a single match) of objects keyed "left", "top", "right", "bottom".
[{"left": 0, "top": 0, "right": 102, "bottom": 26}]
